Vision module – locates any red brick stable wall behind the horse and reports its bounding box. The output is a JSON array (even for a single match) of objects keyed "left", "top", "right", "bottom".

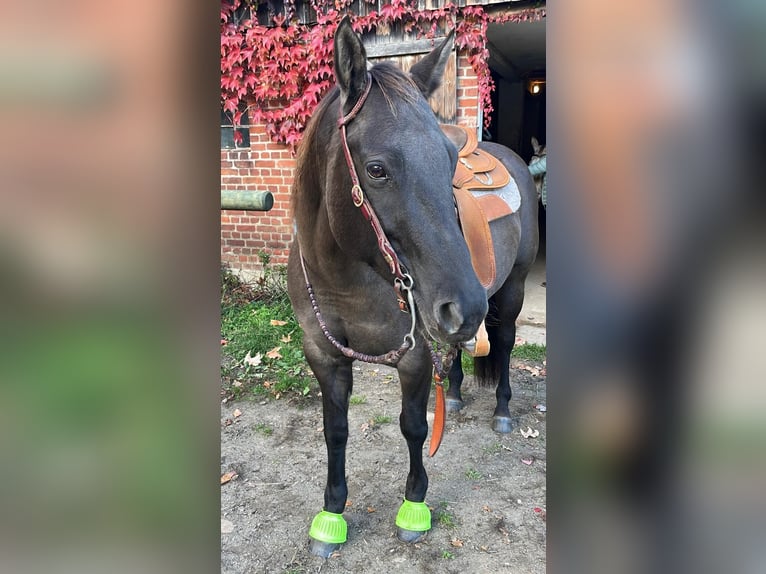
[{"left": 221, "top": 54, "right": 479, "bottom": 277}]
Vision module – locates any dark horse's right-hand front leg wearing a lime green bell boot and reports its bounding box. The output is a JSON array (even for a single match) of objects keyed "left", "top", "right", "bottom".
[{"left": 396, "top": 354, "right": 432, "bottom": 542}]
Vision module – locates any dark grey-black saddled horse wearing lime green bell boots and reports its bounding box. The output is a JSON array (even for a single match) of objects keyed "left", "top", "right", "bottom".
[{"left": 287, "top": 17, "right": 537, "bottom": 557}]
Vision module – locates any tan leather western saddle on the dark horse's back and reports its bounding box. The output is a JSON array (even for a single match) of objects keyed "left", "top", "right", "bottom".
[{"left": 441, "top": 124, "right": 512, "bottom": 357}]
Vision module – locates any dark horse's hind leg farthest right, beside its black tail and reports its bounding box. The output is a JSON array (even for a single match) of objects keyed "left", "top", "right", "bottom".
[{"left": 474, "top": 268, "right": 527, "bottom": 434}]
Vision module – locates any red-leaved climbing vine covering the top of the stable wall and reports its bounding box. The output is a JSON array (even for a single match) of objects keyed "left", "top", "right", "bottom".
[{"left": 221, "top": 0, "right": 545, "bottom": 150}]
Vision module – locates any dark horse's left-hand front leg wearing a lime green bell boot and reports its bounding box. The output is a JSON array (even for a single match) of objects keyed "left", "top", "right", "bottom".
[{"left": 306, "top": 352, "right": 353, "bottom": 558}]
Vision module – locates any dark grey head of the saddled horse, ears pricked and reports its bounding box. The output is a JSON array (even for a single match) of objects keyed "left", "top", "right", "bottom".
[{"left": 324, "top": 19, "right": 487, "bottom": 343}]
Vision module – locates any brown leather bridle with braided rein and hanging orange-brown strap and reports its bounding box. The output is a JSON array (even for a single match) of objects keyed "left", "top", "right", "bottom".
[{"left": 298, "top": 72, "right": 457, "bottom": 456}]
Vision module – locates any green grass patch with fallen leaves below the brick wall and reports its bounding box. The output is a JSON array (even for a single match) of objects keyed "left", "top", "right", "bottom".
[{"left": 221, "top": 270, "right": 314, "bottom": 398}]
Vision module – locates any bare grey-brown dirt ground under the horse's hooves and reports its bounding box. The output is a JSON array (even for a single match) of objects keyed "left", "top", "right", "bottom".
[{"left": 221, "top": 359, "right": 546, "bottom": 574}]
